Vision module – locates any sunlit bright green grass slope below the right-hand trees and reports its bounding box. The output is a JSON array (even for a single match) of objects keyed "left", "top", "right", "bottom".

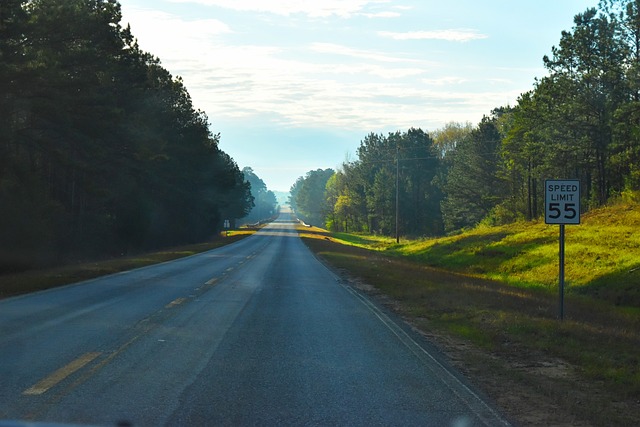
[{"left": 331, "top": 203, "right": 640, "bottom": 307}]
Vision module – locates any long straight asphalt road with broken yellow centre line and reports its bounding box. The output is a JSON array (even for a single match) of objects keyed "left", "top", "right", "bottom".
[{"left": 0, "top": 214, "right": 508, "bottom": 427}]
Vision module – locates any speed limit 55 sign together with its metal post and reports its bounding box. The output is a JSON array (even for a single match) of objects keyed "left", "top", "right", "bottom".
[{"left": 544, "top": 179, "right": 580, "bottom": 320}]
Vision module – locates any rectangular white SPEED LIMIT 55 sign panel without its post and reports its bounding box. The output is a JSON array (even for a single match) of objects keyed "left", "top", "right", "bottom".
[{"left": 544, "top": 179, "right": 580, "bottom": 224}]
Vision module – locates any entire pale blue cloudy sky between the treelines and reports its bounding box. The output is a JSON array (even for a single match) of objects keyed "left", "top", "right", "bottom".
[{"left": 120, "top": 0, "right": 598, "bottom": 191}]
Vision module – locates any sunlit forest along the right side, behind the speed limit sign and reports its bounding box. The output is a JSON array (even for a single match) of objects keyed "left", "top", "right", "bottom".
[{"left": 291, "top": 0, "right": 640, "bottom": 236}]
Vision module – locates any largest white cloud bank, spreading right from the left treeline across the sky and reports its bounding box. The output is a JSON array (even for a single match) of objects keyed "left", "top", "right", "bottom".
[{"left": 123, "top": 0, "right": 519, "bottom": 132}]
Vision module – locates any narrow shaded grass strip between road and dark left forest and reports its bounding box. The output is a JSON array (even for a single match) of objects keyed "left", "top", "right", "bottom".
[{"left": 0, "top": 228, "right": 256, "bottom": 298}]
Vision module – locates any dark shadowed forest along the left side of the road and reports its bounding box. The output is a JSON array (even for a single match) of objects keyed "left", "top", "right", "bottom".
[{"left": 0, "top": 0, "right": 253, "bottom": 272}]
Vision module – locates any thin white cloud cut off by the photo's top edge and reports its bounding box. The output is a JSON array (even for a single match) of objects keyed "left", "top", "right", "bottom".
[{"left": 170, "top": 0, "right": 387, "bottom": 18}]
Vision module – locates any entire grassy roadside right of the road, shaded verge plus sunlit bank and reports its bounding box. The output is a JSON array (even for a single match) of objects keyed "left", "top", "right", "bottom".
[{"left": 301, "top": 203, "right": 640, "bottom": 425}]
